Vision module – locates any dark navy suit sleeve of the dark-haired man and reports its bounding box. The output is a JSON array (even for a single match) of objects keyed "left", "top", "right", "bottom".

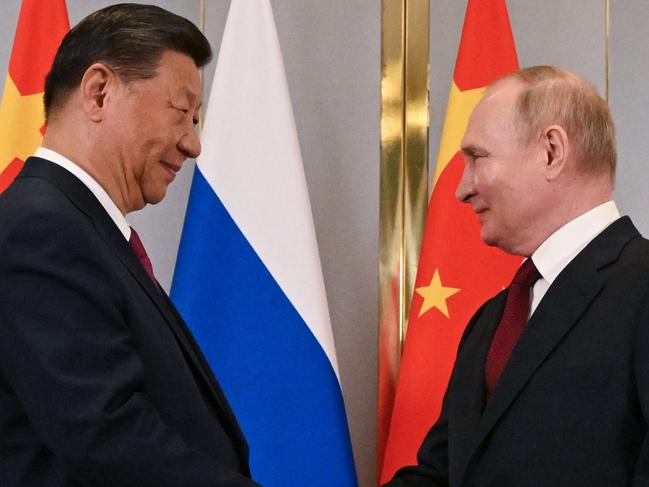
[{"left": 0, "top": 213, "right": 259, "bottom": 487}]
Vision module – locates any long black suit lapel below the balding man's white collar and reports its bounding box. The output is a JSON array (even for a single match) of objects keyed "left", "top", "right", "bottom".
[{"left": 460, "top": 217, "right": 639, "bottom": 476}]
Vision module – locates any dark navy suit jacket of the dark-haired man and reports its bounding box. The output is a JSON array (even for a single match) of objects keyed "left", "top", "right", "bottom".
[{"left": 0, "top": 158, "right": 258, "bottom": 487}]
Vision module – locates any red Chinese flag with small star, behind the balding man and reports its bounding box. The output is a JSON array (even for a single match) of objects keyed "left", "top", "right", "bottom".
[{"left": 381, "top": 0, "right": 521, "bottom": 483}]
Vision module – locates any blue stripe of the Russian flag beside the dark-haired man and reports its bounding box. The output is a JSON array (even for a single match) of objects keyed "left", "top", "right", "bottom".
[{"left": 171, "top": 168, "right": 357, "bottom": 487}]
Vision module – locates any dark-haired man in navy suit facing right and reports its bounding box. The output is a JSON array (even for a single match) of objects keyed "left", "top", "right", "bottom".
[{"left": 0, "top": 4, "right": 259, "bottom": 487}]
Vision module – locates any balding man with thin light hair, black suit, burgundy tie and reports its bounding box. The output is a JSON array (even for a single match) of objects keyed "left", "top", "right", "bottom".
[{"left": 386, "top": 66, "right": 649, "bottom": 487}]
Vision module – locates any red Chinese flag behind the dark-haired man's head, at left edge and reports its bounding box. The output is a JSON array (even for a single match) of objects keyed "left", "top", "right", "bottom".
[{"left": 0, "top": 0, "right": 70, "bottom": 193}]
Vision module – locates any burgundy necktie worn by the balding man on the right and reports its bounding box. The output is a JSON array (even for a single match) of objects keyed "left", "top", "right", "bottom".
[{"left": 485, "top": 258, "right": 541, "bottom": 395}]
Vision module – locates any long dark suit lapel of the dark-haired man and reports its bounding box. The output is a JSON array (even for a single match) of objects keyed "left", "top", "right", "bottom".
[{"left": 19, "top": 157, "right": 247, "bottom": 458}]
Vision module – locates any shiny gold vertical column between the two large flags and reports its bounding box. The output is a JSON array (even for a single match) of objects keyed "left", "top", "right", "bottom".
[{"left": 377, "top": 0, "right": 429, "bottom": 474}]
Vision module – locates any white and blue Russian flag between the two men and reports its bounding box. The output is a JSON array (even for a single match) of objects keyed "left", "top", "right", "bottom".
[{"left": 171, "top": 0, "right": 357, "bottom": 487}]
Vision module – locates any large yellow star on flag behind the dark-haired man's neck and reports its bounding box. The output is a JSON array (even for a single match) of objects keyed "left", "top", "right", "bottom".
[{"left": 0, "top": 76, "right": 45, "bottom": 172}]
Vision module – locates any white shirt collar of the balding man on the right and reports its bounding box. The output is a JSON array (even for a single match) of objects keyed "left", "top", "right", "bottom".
[{"left": 530, "top": 201, "right": 620, "bottom": 316}]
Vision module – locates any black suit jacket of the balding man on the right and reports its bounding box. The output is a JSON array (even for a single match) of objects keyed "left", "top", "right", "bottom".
[{"left": 388, "top": 217, "right": 649, "bottom": 487}]
